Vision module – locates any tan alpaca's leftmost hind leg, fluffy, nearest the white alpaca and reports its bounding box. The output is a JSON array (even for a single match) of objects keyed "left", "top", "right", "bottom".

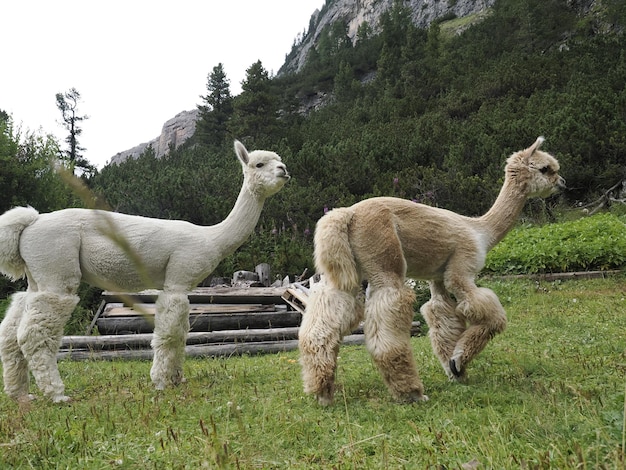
[{"left": 298, "top": 287, "right": 363, "bottom": 405}]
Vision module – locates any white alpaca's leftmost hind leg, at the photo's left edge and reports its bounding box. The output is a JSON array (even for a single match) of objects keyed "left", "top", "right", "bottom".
[{"left": 0, "top": 292, "right": 29, "bottom": 400}]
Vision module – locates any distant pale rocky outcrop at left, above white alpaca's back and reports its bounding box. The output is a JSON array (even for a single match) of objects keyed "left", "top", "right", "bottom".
[{"left": 111, "top": 109, "right": 198, "bottom": 164}]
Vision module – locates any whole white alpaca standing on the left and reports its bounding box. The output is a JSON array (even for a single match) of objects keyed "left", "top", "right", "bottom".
[{"left": 0, "top": 141, "right": 289, "bottom": 402}]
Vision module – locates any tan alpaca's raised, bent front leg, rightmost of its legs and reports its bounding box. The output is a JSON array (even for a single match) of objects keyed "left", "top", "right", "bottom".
[{"left": 450, "top": 287, "right": 506, "bottom": 377}]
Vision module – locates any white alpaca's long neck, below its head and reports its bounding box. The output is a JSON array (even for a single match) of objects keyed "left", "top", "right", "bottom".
[{"left": 208, "top": 183, "right": 265, "bottom": 257}]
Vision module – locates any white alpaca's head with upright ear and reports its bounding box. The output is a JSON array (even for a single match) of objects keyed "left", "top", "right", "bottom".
[{"left": 235, "top": 140, "right": 291, "bottom": 198}]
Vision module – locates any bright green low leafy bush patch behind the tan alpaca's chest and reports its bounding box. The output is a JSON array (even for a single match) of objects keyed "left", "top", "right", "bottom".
[{"left": 485, "top": 213, "right": 626, "bottom": 274}]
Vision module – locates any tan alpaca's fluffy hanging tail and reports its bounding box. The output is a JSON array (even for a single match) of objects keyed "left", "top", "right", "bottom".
[{"left": 314, "top": 207, "right": 360, "bottom": 292}]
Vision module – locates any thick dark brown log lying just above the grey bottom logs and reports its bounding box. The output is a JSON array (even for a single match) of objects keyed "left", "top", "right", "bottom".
[{"left": 96, "top": 311, "right": 302, "bottom": 335}]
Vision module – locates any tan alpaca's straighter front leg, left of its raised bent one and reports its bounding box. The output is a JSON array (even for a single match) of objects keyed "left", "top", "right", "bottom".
[{"left": 420, "top": 281, "right": 466, "bottom": 380}]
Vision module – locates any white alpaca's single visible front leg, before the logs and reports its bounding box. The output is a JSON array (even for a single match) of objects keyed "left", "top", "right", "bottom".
[{"left": 150, "top": 292, "right": 189, "bottom": 390}]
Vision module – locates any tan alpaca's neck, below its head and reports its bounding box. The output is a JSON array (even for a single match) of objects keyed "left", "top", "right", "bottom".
[{"left": 478, "top": 175, "right": 526, "bottom": 250}]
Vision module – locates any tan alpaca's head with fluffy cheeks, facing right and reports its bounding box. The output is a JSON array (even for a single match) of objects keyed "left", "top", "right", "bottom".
[{"left": 506, "top": 137, "right": 565, "bottom": 198}]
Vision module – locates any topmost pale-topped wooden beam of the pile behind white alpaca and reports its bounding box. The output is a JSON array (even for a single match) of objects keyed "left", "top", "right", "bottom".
[{"left": 102, "top": 287, "right": 286, "bottom": 305}]
